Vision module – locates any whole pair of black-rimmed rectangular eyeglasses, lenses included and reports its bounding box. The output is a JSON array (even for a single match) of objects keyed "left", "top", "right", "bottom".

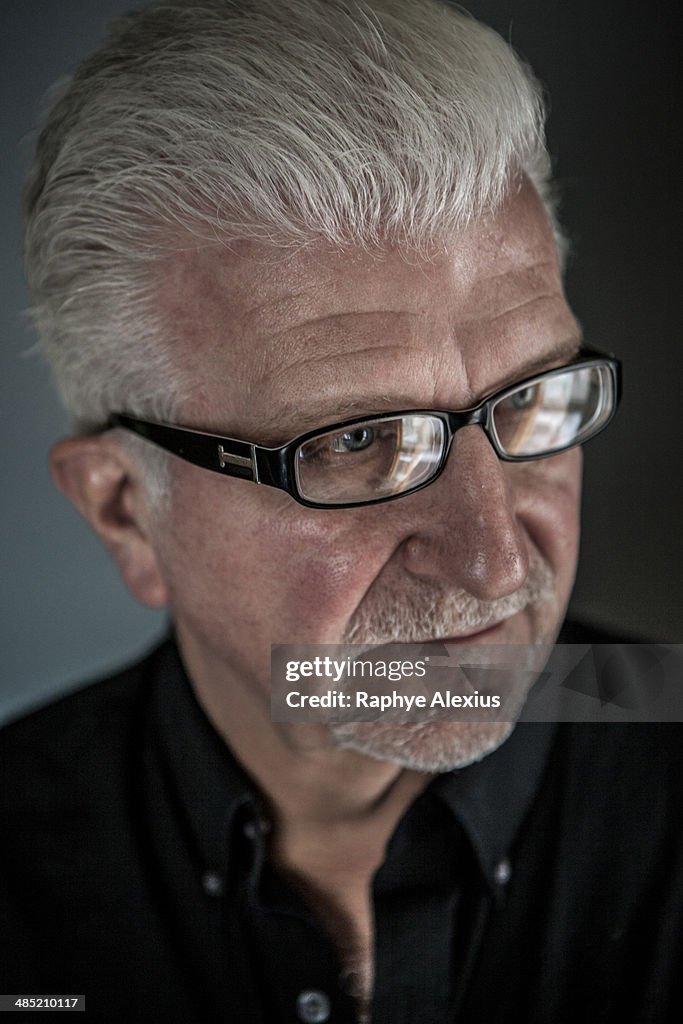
[{"left": 108, "top": 348, "right": 621, "bottom": 508}]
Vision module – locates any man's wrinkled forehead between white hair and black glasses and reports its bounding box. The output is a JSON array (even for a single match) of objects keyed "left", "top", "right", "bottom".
[{"left": 156, "top": 186, "right": 577, "bottom": 442}]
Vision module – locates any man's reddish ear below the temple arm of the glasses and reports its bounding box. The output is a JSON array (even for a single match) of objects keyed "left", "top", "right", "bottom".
[{"left": 50, "top": 435, "right": 168, "bottom": 608}]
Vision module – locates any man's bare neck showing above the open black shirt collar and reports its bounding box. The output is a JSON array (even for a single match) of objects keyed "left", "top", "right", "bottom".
[{"left": 178, "top": 631, "right": 431, "bottom": 1020}]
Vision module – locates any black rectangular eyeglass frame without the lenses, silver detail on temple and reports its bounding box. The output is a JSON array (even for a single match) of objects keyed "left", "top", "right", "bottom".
[{"left": 106, "top": 347, "right": 622, "bottom": 509}]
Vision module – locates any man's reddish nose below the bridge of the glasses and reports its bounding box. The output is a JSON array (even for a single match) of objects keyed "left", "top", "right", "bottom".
[{"left": 402, "top": 426, "right": 529, "bottom": 600}]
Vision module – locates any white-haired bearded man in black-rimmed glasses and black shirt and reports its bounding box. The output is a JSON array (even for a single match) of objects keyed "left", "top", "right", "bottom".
[{"left": 2, "top": 0, "right": 683, "bottom": 1024}]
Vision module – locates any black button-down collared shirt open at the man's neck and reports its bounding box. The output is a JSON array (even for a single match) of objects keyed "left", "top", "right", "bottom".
[{"left": 0, "top": 626, "right": 683, "bottom": 1024}]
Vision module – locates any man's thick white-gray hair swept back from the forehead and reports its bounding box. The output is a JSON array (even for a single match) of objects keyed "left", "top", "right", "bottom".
[{"left": 26, "top": 0, "right": 551, "bottom": 431}]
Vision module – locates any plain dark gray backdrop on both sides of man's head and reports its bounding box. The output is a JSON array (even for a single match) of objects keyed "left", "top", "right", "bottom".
[{"left": 0, "top": 0, "right": 683, "bottom": 715}]
